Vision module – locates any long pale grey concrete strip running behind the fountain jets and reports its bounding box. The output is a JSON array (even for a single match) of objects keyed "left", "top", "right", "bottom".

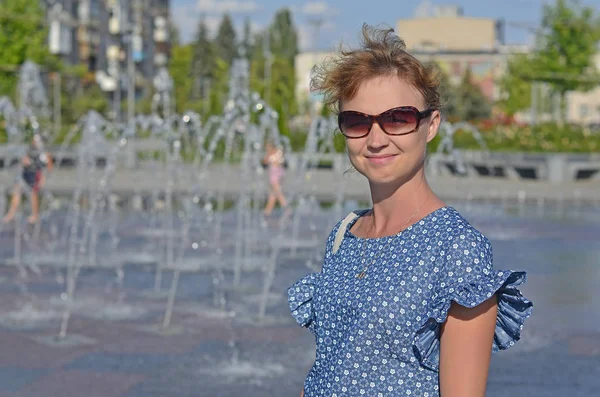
[{"left": 0, "top": 165, "right": 600, "bottom": 203}]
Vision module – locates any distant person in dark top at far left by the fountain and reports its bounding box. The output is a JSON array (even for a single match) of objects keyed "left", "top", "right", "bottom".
[{"left": 2, "top": 134, "right": 52, "bottom": 223}]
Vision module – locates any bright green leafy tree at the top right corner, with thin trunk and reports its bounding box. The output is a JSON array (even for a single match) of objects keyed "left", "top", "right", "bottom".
[{"left": 523, "top": 0, "right": 600, "bottom": 120}]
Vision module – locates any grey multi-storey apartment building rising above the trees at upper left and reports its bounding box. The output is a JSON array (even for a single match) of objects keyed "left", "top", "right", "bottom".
[{"left": 42, "top": 0, "right": 170, "bottom": 91}]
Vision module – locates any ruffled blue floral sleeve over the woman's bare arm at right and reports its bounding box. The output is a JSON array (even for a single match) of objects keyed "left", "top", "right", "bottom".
[{"left": 413, "top": 229, "right": 533, "bottom": 371}]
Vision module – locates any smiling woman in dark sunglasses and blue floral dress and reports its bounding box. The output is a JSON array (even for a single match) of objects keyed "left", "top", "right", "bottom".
[{"left": 288, "top": 26, "right": 532, "bottom": 397}]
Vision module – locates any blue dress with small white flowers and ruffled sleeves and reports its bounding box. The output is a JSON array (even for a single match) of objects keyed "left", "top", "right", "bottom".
[{"left": 288, "top": 207, "right": 533, "bottom": 397}]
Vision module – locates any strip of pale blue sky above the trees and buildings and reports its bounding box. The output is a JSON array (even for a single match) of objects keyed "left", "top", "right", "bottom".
[{"left": 171, "top": 0, "right": 600, "bottom": 49}]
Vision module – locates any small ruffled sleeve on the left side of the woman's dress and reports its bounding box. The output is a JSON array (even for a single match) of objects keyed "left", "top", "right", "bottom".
[{"left": 287, "top": 273, "right": 321, "bottom": 333}]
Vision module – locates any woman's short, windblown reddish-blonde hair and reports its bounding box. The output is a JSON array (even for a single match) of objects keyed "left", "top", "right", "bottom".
[{"left": 310, "top": 24, "right": 441, "bottom": 112}]
